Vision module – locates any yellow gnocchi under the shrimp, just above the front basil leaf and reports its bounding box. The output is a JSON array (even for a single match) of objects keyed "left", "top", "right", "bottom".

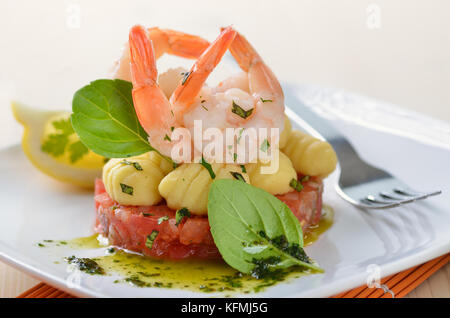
[{"left": 245, "top": 152, "right": 297, "bottom": 195}]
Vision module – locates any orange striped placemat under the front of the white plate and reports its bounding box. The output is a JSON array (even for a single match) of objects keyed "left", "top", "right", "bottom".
[{"left": 17, "top": 253, "right": 450, "bottom": 298}]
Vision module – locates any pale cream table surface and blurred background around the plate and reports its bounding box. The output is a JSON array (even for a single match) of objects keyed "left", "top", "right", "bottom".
[{"left": 0, "top": 0, "right": 450, "bottom": 297}]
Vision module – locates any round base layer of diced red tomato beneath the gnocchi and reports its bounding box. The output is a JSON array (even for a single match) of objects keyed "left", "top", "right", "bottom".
[{"left": 95, "top": 176, "right": 323, "bottom": 260}]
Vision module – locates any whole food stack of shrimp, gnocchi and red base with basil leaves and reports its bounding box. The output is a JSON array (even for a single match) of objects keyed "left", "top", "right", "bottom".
[{"left": 72, "top": 26, "right": 337, "bottom": 268}]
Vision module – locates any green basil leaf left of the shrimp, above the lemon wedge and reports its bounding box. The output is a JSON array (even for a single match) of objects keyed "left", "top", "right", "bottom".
[{"left": 71, "top": 79, "right": 154, "bottom": 158}]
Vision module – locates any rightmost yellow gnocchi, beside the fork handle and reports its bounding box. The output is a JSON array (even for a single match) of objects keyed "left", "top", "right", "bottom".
[{"left": 282, "top": 130, "right": 338, "bottom": 177}]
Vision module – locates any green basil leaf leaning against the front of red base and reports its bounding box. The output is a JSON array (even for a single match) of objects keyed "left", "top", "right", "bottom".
[{"left": 208, "top": 179, "right": 323, "bottom": 278}]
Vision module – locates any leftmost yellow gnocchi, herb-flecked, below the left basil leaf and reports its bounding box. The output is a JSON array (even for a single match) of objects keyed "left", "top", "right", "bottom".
[{"left": 103, "top": 151, "right": 172, "bottom": 205}]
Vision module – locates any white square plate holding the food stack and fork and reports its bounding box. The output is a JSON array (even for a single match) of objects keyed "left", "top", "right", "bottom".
[{"left": 0, "top": 86, "right": 450, "bottom": 297}]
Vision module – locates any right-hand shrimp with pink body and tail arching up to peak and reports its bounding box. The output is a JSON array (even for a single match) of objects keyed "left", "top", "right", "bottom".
[{"left": 177, "top": 29, "right": 284, "bottom": 163}]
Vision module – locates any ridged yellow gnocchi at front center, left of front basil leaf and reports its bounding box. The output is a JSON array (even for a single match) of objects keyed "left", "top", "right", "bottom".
[{"left": 158, "top": 163, "right": 250, "bottom": 215}]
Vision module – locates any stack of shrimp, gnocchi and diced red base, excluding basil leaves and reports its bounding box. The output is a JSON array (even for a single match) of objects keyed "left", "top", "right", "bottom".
[{"left": 95, "top": 27, "right": 337, "bottom": 259}]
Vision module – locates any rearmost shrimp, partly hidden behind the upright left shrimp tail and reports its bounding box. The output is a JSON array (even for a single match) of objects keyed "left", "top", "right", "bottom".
[{"left": 110, "top": 27, "right": 209, "bottom": 81}]
